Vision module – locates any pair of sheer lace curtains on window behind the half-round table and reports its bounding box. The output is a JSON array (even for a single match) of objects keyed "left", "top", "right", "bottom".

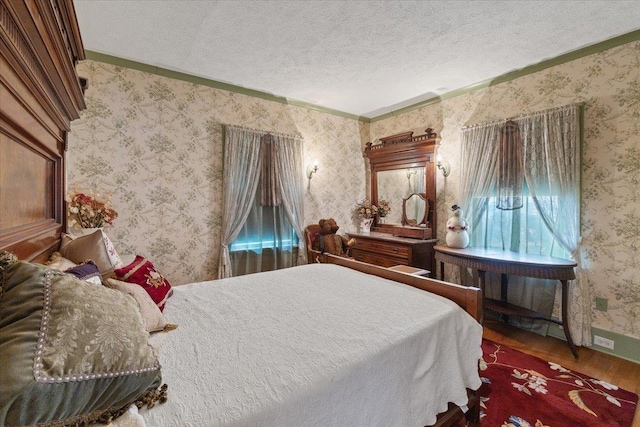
[{"left": 460, "top": 105, "right": 591, "bottom": 345}]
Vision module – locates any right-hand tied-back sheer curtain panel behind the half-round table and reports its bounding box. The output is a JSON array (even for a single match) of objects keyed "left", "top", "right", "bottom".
[{"left": 516, "top": 105, "right": 592, "bottom": 346}]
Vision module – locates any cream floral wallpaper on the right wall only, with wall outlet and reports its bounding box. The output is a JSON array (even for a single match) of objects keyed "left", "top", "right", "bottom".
[{"left": 370, "top": 42, "right": 640, "bottom": 338}]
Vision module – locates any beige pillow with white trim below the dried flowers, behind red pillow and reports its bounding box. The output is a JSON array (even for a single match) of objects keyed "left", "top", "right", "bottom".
[{"left": 60, "top": 229, "right": 121, "bottom": 279}]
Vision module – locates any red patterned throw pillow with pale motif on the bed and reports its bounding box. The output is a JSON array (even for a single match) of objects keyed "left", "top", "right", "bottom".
[{"left": 115, "top": 255, "right": 173, "bottom": 311}]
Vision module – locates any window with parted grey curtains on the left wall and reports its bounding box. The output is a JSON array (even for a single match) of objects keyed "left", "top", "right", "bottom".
[{"left": 218, "top": 126, "right": 306, "bottom": 278}]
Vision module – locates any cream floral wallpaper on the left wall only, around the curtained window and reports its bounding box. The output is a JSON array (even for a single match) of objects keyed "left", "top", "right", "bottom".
[{"left": 67, "top": 60, "right": 367, "bottom": 285}]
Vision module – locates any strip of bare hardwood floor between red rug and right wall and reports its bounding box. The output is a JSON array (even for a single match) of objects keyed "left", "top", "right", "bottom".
[{"left": 483, "top": 320, "right": 640, "bottom": 427}]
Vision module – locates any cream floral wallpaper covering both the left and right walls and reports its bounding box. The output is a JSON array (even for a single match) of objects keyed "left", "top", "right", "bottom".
[{"left": 67, "top": 42, "right": 640, "bottom": 346}]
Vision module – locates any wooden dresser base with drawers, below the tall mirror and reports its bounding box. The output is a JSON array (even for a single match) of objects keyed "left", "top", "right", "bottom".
[{"left": 347, "top": 231, "right": 438, "bottom": 277}]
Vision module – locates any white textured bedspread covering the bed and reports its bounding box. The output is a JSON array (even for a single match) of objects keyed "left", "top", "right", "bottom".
[{"left": 140, "top": 264, "right": 482, "bottom": 427}]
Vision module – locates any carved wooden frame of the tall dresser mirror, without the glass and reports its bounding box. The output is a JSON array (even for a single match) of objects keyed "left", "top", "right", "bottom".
[{"left": 364, "top": 128, "right": 440, "bottom": 236}]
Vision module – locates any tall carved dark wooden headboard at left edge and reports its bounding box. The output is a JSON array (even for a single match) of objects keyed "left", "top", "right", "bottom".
[{"left": 0, "top": 0, "right": 85, "bottom": 261}]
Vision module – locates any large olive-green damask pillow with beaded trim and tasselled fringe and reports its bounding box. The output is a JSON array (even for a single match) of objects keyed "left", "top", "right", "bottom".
[{"left": 0, "top": 262, "right": 166, "bottom": 426}]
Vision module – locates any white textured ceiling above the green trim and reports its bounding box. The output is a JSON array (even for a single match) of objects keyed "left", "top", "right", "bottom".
[{"left": 74, "top": 0, "right": 640, "bottom": 117}]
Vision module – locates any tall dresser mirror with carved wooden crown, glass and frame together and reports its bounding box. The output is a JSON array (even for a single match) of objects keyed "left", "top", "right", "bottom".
[{"left": 364, "top": 128, "right": 440, "bottom": 236}]
